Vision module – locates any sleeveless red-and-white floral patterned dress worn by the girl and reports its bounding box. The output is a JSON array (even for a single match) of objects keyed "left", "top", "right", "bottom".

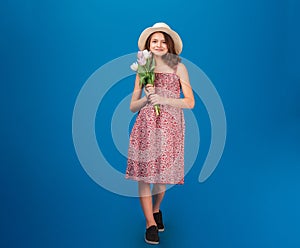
[{"left": 125, "top": 73, "right": 185, "bottom": 184}]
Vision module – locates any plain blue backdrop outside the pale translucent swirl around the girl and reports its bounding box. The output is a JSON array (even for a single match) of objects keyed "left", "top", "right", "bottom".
[{"left": 0, "top": 0, "right": 300, "bottom": 248}]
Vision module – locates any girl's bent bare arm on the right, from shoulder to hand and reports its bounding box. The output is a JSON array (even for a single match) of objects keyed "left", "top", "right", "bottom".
[{"left": 149, "top": 63, "right": 195, "bottom": 109}]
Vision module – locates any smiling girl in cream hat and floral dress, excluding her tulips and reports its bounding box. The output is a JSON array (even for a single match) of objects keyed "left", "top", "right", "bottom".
[{"left": 126, "top": 23, "right": 195, "bottom": 244}]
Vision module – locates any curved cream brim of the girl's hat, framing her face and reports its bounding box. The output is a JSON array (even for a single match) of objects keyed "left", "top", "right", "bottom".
[{"left": 138, "top": 27, "right": 182, "bottom": 55}]
